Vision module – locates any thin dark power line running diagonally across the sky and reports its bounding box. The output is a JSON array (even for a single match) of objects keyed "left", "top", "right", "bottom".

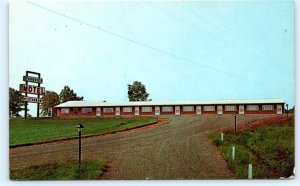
[{"left": 27, "top": 1, "right": 278, "bottom": 85}]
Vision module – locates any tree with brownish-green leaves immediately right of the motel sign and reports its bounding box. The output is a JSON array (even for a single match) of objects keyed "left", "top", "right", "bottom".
[{"left": 41, "top": 91, "right": 60, "bottom": 116}]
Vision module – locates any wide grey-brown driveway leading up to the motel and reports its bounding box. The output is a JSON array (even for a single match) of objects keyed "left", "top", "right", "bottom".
[{"left": 10, "top": 115, "right": 270, "bottom": 179}]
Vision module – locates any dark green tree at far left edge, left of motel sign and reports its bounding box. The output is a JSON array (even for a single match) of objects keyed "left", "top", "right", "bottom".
[{"left": 9, "top": 87, "right": 25, "bottom": 117}]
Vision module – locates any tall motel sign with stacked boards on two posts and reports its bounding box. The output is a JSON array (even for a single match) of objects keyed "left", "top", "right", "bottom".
[{"left": 20, "top": 71, "right": 45, "bottom": 119}]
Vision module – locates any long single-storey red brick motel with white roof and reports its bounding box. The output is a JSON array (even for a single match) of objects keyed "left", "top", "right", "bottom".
[{"left": 55, "top": 99, "right": 284, "bottom": 118}]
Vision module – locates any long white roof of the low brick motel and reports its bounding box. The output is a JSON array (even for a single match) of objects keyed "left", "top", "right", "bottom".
[{"left": 55, "top": 99, "right": 284, "bottom": 108}]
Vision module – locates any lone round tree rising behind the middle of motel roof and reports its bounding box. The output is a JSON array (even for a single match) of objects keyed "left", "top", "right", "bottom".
[{"left": 128, "top": 81, "right": 149, "bottom": 101}]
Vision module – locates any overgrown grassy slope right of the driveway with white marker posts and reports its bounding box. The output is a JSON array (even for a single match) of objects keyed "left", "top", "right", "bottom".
[{"left": 209, "top": 120, "right": 295, "bottom": 179}]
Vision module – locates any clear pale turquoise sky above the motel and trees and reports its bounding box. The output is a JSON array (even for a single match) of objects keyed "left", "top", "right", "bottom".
[{"left": 9, "top": 0, "right": 295, "bottom": 115}]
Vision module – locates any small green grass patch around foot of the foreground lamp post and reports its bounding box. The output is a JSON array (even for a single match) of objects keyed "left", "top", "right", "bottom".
[{"left": 10, "top": 160, "right": 104, "bottom": 180}]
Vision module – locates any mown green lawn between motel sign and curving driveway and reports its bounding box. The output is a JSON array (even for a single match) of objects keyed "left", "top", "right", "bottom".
[{"left": 9, "top": 117, "right": 157, "bottom": 146}]
